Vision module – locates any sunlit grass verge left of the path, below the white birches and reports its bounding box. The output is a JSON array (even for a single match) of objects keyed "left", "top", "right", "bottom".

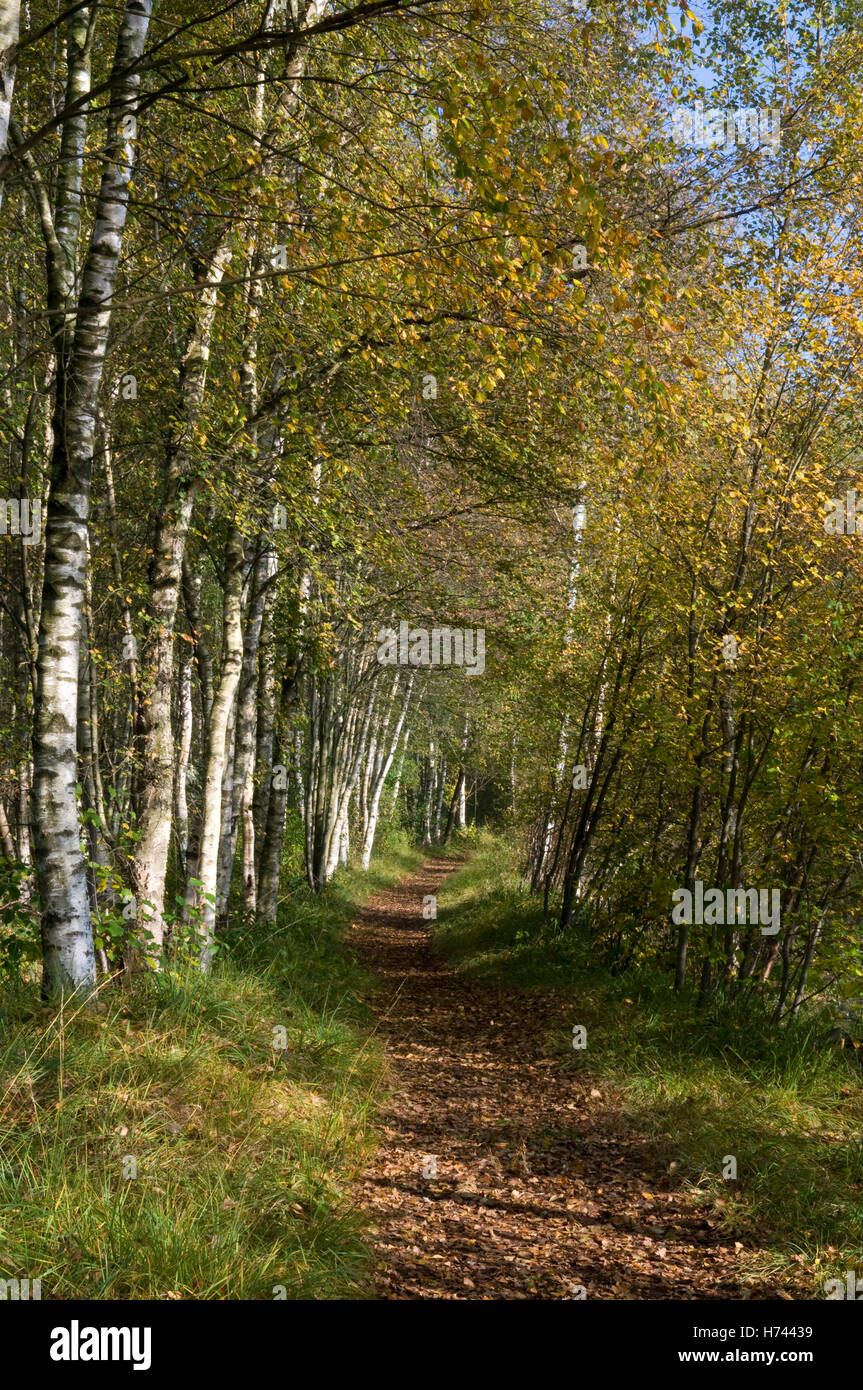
[{"left": 0, "top": 842, "right": 417, "bottom": 1300}]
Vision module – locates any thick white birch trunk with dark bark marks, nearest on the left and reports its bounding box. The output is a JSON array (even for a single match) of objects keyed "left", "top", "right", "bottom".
[{"left": 33, "top": 0, "right": 151, "bottom": 998}]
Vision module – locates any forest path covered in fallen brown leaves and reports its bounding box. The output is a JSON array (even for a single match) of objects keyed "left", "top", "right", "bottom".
[{"left": 350, "top": 859, "right": 777, "bottom": 1300}]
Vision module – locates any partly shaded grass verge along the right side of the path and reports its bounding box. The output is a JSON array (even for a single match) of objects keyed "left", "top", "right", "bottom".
[{"left": 436, "top": 835, "right": 863, "bottom": 1297}]
